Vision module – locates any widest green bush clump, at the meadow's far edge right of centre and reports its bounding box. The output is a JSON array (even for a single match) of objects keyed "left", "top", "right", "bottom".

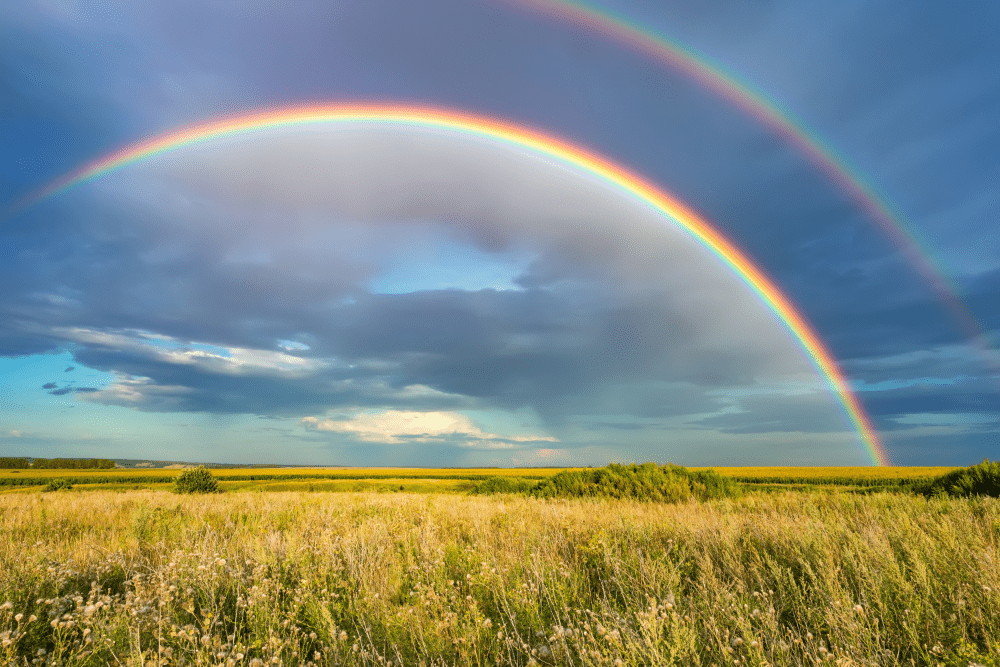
[{"left": 529, "top": 463, "right": 742, "bottom": 502}]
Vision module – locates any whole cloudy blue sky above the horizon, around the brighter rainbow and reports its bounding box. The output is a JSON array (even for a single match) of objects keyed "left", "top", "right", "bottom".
[{"left": 0, "top": 0, "right": 1000, "bottom": 467}]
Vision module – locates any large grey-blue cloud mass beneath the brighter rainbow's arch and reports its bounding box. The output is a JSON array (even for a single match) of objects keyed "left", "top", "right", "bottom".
[{"left": 0, "top": 124, "right": 828, "bottom": 434}]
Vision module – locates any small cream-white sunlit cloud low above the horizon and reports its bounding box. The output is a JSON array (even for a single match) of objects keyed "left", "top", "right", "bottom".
[{"left": 302, "top": 410, "right": 558, "bottom": 449}]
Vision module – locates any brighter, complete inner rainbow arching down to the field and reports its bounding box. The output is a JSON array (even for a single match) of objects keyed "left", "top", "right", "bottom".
[{"left": 15, "top": 104, "right": 890, "bottom": 465}]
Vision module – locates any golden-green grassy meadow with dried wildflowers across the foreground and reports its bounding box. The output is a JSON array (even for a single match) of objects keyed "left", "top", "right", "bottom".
[{"left": 0, "top": 469, "right": 1000, "bottom": 667}]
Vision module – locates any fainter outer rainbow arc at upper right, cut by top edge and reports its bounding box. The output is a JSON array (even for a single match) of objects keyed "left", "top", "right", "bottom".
[{"left": 503, "top": 0, "right": 989, "bottom": 349}]
